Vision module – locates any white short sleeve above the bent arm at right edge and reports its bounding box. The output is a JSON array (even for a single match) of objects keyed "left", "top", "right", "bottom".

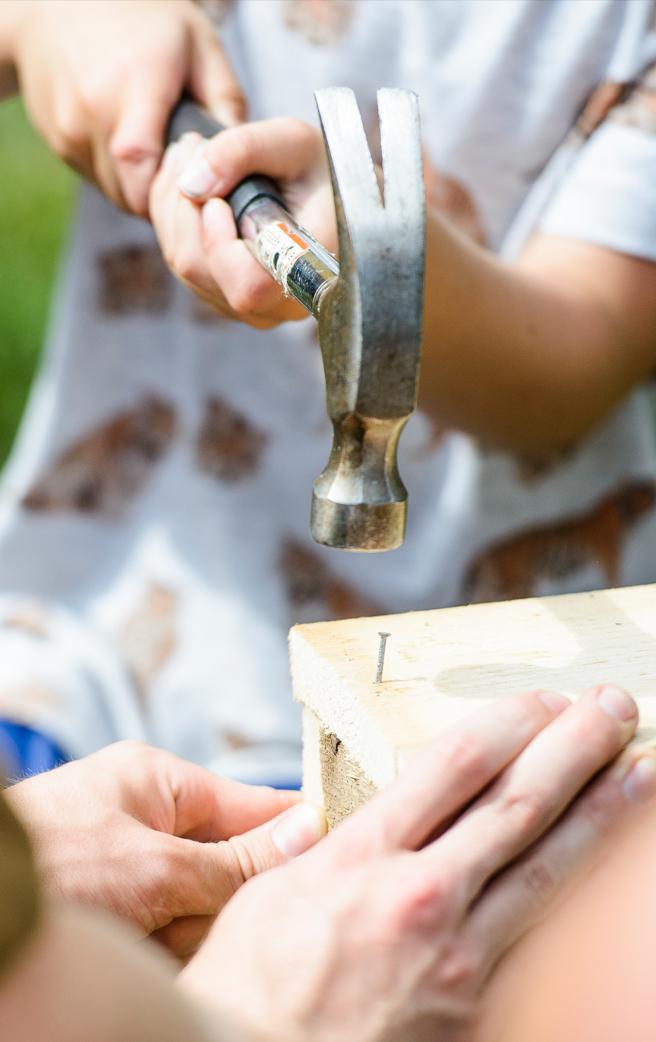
[{"left": 539, "top": 66, "right": 656, "bottom": 261}]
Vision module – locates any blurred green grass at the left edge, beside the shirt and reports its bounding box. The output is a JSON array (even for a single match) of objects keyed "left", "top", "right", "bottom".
[{"left": 0, "top": 98, "right": 75, "bottom": 462}]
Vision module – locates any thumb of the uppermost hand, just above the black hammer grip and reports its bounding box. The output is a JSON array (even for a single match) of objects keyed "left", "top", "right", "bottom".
[{"left": 188, "top": 25, "right": 248, "bottom": 127}]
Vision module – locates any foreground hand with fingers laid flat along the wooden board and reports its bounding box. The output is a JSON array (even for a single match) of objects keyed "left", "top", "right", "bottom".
[{"left": 182, "top": 689, "right": 656, "bottom": 1042}]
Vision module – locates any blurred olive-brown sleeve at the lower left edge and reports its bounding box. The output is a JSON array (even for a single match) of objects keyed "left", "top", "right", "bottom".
[{"left": 0, "top": 792, "right": 40, "bottom": 983}]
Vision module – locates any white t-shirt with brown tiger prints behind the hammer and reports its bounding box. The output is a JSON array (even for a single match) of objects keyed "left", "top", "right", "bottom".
[{"left": 0, "top": 0, "right": 656, "bottom": 782}]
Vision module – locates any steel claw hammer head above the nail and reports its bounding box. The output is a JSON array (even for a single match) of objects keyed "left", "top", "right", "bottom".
[{"left": 311, "top": 88, "right": 425, "bottom": 551}]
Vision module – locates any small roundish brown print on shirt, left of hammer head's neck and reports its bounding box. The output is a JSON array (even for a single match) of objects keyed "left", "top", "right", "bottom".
[{"left": 196, "top": 398, "right": 269, "bottom": 481}]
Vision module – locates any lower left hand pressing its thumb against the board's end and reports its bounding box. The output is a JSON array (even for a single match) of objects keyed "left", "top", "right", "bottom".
[{"left": 6, "top": 742, "right": 325, "bottom": 960}]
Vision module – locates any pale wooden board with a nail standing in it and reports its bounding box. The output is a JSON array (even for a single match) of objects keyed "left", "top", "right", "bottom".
[{"left": 289, "top": 586, "right": 656, "bottom": 824}]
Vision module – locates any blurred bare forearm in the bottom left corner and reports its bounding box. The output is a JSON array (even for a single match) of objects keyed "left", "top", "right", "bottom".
[{"left": 0, "top": 910, "right": 241, "bottom": 1042}]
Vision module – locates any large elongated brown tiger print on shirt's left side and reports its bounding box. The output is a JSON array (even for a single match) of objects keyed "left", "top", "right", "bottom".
[{"left": 22, "top": 396, "right": 176, "bottom": 517}]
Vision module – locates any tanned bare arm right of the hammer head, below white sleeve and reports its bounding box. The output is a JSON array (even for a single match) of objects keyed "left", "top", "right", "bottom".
[{"left": 421, "top": 214, "right": 654, "bottom": 453}]
